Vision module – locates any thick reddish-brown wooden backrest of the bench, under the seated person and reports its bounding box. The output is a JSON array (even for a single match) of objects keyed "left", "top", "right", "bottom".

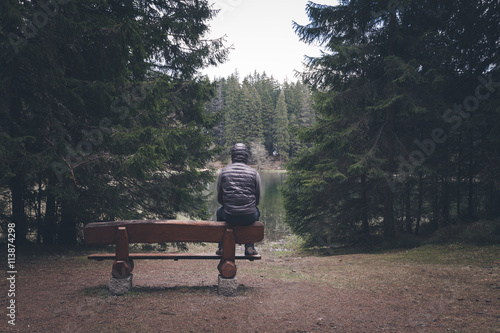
[{"left": 83, "top": 220, "right": 264, "bottom": 244}]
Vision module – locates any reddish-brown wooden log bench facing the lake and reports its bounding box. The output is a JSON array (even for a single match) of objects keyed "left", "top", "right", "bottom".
[{"left": 83, "top": 220, "right": 264, "bottom": 279}]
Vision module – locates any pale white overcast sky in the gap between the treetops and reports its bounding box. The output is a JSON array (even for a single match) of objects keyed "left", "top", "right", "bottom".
[{"left": 203, "top": 0, "right": 330, "bottom": 82}]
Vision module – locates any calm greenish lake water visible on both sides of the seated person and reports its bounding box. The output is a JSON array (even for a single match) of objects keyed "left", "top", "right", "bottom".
[{"left": 209, "top": 171, "right": 291, "bottom": 241}]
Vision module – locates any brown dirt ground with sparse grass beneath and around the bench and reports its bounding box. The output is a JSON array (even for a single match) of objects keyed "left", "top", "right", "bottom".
[{"left": 0, "top": 241, "right": 500, "bottom": 333}]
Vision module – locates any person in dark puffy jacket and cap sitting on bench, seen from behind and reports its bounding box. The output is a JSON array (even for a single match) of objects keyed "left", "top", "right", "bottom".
[{"left": 216, "top": 143, "right": 260, "bottom": 255}]
